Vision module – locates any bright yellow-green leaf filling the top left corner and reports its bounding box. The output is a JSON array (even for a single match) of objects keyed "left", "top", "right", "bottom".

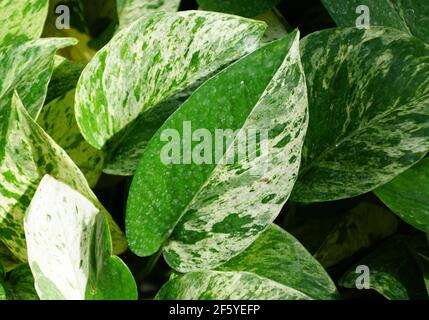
[{"left": 0, "top": 0, "right": 49, "bottom": 41}]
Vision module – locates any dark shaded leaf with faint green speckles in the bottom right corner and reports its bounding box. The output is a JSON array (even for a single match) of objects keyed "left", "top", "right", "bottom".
[{"left": 340, "top": 237, "right": 428, "bottom": 300}]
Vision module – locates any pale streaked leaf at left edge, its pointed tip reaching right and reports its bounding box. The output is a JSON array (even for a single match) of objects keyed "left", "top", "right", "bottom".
[{"left": 0, "top": 38, "right": 76, "bottom": 118}]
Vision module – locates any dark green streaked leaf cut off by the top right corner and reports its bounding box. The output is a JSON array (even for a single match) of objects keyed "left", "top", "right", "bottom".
[{"left": 322, "top": 0, "right": 429, "bottom": 42}]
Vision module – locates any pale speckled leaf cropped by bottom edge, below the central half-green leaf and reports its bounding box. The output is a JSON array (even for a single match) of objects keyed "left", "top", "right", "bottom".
[{"left": 156, "top": 271, "right": 311, "bottom": 300}]
